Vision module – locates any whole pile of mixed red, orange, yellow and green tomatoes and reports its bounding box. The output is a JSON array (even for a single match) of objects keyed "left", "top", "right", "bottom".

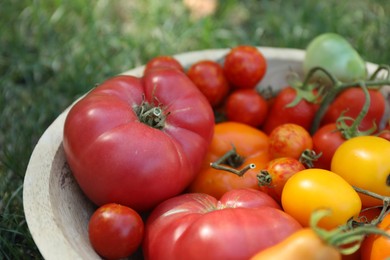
[{"left": 63, "top": 34, "right": 390, "bottom": 260}]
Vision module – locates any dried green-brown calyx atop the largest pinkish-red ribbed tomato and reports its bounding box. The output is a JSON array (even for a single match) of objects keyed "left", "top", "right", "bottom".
[{"left": 134, "top": 97, "right": 169, "bottom": 130}]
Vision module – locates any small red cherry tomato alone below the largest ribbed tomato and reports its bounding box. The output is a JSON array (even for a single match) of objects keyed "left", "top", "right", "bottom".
[{"left": 88, "top": 203, "right": 144, "bottom": 259}]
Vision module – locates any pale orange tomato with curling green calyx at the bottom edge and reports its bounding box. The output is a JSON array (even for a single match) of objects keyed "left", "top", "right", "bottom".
[{"left": 250, "top": 209, "right": 382, "bottom": 260}]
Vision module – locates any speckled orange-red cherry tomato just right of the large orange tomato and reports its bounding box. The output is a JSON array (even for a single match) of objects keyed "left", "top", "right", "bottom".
[{"left": 269, "top": 124, "right": 313, "bottom": 160}]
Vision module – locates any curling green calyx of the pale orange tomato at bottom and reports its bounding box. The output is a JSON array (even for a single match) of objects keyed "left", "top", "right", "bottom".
[{"left": 310, "top": 209, "right": 390, "bottom": 255}]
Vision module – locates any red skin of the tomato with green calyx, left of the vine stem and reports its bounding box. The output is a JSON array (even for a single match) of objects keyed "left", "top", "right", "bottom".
[{"left": 262, "top": 86, "right": 319, "bottom": 134}]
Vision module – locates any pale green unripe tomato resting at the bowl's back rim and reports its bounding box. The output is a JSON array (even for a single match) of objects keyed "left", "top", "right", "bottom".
[{"left": 303, "top": 33, "right": 367, "bottom": 82}]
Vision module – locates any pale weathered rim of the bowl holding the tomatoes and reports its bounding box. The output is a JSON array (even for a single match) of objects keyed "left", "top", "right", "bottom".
[{"left": 23, "top": 46, "right": 377, "bottom": 259}]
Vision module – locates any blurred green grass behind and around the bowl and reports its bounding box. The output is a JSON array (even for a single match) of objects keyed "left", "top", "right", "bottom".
[{"left": 0, "top": 0, "right": 390, "bottom": 259}]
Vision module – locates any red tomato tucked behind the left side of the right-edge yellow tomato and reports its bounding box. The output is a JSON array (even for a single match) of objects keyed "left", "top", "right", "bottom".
[{"left": 312, "top": 123, "right": 346, "bottom": 170}]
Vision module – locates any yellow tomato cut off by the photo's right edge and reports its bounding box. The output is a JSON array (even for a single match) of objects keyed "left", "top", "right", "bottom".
[{"left": 331, "top": 136, "right": 390, "bottom": 207}]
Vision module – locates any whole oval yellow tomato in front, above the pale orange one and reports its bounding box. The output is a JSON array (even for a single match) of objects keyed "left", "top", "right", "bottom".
[{"left": 282, "top": 168, "right": 362, "bottom": 229}]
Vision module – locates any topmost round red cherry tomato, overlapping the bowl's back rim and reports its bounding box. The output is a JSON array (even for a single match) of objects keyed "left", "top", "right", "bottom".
[{"left": 223, "top": 45, "right": 267, "bottom": 88}]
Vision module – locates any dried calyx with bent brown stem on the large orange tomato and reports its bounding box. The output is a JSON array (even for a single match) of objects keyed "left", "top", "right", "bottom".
[{"left": 210, "top": 145, "right": 256, "bottom": 177}]
